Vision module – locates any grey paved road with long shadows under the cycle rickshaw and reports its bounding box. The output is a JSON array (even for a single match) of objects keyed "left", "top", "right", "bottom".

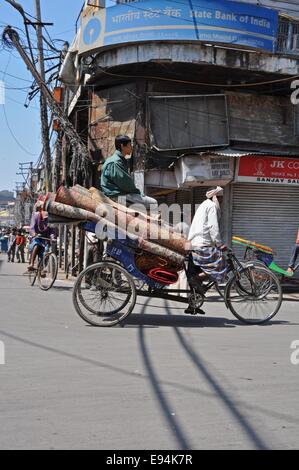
[{"left": 0, "top": 255, "right": 299, "bottom": 449}]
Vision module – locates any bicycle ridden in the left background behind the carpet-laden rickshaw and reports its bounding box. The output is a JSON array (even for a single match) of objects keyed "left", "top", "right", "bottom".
[{"left": 29, "top": 237, "right": 58, "bottom": 291}]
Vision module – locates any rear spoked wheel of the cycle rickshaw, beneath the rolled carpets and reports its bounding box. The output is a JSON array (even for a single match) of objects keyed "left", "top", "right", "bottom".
[{"left": 73, "top": 261, "right": 136, "bottom": 326}]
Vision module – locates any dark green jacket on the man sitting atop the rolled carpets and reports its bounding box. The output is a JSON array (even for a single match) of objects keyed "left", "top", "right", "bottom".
[{"left": 101, "top": 150, "right": 141, "bottom": 197}]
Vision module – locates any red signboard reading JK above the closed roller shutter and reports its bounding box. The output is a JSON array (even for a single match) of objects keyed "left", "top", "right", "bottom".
[{"left": 236, "top": 155, "right": 299, "bottom": 185}]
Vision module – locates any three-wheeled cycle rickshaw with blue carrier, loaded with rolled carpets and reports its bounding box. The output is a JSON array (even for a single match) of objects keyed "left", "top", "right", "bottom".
[{"left": 73, "top": 226, "right": 282, "bottom": 327}]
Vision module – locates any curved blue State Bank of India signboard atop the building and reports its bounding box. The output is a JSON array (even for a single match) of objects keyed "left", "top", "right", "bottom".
[{"left": 80, "top": 0, "right": 278, "bottom": 53}]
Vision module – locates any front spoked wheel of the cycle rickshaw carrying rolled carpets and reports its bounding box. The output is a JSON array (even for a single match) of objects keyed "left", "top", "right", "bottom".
[{"left": 225, "top": 265, "right": 282, "bottom": 325}]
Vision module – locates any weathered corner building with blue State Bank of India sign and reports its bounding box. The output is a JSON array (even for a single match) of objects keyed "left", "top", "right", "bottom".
[{"left": 61, "top": 0, "right": 299, "bottom": 266}]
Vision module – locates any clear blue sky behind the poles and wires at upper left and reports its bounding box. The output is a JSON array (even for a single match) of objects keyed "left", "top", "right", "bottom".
[{"left": 0, "top": 0, "right": 115, "bottom": 191}]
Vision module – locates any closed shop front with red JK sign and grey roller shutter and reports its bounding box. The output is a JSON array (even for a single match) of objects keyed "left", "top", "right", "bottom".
[{"left": 231, "top": 155, "right": 299, "bottom": 268}]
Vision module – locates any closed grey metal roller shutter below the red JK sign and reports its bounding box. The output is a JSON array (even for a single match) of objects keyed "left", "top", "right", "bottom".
[{"left": 232, "top": 184, "right": 299, "bottom": 274}]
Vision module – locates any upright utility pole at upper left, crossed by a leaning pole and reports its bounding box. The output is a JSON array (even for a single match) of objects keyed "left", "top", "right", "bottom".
[{"left": 35, "top": 0, "right": 52, "bottom": 192}]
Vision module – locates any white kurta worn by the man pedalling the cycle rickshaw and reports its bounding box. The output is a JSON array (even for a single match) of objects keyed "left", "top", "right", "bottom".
[{"left": 188, "top": 199, "right": 222, "bottom": 248}]
